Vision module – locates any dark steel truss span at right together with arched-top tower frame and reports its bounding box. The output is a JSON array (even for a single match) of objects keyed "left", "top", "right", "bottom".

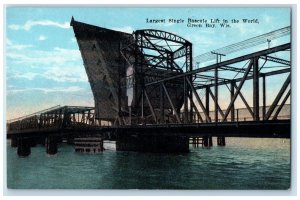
[{"left": 124, "top": 37, "right": 291, "bottom": 124}]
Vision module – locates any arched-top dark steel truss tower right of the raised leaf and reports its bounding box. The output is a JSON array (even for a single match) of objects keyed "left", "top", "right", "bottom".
[{"left": 121, "top": 29, "right": 193, "bottom": 123}]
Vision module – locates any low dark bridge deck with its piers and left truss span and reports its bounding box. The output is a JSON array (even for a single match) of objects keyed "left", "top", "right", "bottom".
[{"left": 7, "top": 106, "right": 290, "bottom": 156}]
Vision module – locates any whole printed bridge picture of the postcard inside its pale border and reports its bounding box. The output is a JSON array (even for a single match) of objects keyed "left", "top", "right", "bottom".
[{"left": 4, "top": 6, "right": 293, "bottom": 190}]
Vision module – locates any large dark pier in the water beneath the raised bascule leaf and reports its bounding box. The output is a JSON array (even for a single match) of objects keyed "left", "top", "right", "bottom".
[{"left": 116, "top": 135, "right": 189, "bottom": 153}]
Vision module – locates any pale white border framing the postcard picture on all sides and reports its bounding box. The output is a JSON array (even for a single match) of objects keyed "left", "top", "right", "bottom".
[{"left": 0, "top": 0, "right": 300, "bottom": 200}]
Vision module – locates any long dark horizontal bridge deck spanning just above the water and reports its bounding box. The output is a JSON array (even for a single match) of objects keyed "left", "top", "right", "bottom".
[{"left": 7, "top": 120, "right": 290, "bottom": 140}]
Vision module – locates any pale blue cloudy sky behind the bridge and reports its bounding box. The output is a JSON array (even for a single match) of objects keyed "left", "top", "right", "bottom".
[{"left": 4, "top": 6, "right": 290, "bottom": 119}]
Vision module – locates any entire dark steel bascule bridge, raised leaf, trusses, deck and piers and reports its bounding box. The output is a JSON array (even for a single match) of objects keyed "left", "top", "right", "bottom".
[{"left": 7, "top": 18, "right": 291, "bottom": 155}]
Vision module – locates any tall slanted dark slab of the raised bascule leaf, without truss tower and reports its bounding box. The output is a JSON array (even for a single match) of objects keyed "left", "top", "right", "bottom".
[{"left": 71, "top": 19, "right": 133, "bottom": 120}]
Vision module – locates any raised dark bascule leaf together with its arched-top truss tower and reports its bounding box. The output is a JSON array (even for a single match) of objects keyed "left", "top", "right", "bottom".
[{"left": 71, "top": 18, "right": 192, "bottom": 124}]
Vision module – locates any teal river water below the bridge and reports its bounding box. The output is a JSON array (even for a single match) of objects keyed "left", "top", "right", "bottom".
[{"left": 7, "top": 138, "right": 290, "bottom": 189}]
